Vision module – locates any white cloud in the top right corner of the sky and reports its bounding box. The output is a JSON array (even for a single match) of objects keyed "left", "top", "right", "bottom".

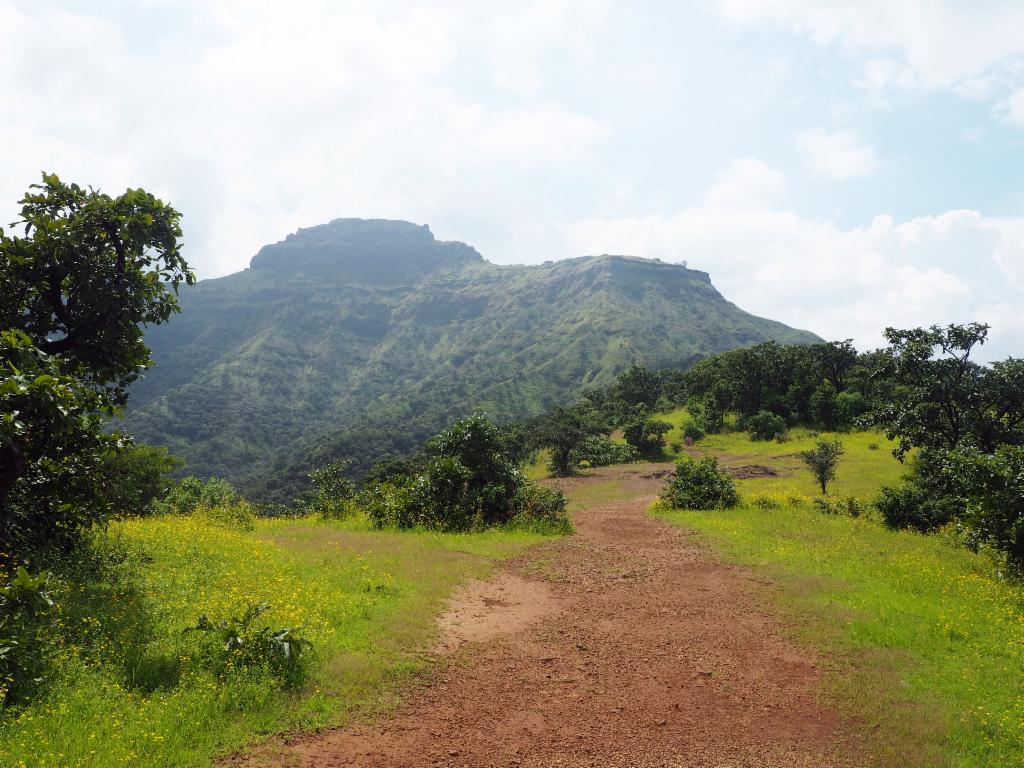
[{"left": 718, "top": 0, "right": 1024, "bottom": 111}]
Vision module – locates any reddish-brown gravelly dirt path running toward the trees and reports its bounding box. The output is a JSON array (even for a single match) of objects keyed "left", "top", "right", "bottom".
[{"left": 240, "top": 469, "right": 849, "bottom": 768}]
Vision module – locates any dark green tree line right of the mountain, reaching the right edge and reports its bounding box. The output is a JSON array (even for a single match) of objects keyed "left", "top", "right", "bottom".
[{"left": 527, "top": 323, "right": 1024, "bottom": 570}]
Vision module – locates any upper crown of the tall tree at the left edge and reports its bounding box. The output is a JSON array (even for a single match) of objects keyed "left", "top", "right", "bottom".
[{"left": 0, "top": 174, "right": 195, "bottom": 406}]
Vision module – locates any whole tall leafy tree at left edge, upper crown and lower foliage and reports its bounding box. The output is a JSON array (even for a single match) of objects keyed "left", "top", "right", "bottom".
[{"left": 0, "top": 174, "right": 195, "bottom": 561}]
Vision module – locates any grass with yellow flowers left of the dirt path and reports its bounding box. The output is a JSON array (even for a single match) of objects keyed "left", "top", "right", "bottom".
[{"left": 0, "top": 517, "right": 541, "bottom": 768}]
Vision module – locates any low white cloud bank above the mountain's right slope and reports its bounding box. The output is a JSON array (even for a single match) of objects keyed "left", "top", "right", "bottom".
[{"left": 569, "top": 158, "right": 1024, "bottom": 357}]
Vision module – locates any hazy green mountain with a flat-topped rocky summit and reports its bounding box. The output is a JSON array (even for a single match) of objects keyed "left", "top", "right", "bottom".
[{"left": 126, "top": 219, "right": 817, "bottom": 500}]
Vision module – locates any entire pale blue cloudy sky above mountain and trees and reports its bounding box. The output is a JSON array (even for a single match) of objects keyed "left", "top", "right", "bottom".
[{"left": 0, "top": 0, "right": 1024, "bottom": 359}]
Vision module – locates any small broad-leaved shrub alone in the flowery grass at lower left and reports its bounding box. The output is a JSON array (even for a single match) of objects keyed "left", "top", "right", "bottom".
[{"left": 184, "top": 603, "right": 309, "bottom": 688}]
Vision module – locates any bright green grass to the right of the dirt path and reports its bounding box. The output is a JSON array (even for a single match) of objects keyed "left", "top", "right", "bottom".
[{"left": 654, "top": 433, "right": 1024, "bottom": 768}]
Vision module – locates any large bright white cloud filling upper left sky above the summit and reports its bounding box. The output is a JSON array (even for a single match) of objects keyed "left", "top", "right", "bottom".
[{"left": 0, "top": 0, "right": 610, "bottom": 276}]
